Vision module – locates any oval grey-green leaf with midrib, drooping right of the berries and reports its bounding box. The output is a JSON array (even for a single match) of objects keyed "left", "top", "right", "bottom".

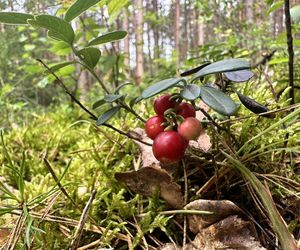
[{"left": 200, "top": 86, "right": 237, "bottom": 115}]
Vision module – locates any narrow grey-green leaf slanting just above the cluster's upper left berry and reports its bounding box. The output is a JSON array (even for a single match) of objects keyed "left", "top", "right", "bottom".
[{"left": 142, "top": 78, "right": 185, "bottom": 99}]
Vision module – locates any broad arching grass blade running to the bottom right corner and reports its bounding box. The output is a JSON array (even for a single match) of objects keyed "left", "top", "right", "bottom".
[{"left": 222, "top": 150, "right": 300, "bottom": 250}]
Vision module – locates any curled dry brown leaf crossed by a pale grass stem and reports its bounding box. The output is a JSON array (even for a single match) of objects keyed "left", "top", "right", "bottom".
[{"left": 185, "top": 200, "right": 243, "bottom": 234}]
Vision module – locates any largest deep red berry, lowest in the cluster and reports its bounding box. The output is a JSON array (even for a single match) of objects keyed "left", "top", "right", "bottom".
[{"left": 152, "top": 131, "right": 186, "bottom": 163}]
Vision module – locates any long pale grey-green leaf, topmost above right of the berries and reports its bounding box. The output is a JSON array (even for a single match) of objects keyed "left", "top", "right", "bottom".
[{"left": 192, "top": 58, "right": 251, "bottom": 81}]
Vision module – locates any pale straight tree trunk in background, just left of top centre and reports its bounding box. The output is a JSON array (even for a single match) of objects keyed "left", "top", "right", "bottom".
[{"left": 135, "top": 0, "right": 144, "bottom": 85}]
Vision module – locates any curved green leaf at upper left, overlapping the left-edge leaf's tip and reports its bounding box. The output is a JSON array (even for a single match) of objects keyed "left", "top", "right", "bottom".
[{"left": 28, "top": 15, "right": 75, "bottom": 44}]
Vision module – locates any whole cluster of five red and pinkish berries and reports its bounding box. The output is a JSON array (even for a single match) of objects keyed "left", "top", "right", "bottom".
[{"left": 145, "top": 95, "right": 202, "bottom": 163}]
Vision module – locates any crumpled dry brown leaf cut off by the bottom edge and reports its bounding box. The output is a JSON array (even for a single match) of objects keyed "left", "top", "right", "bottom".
[{"left": 188, "top": 215, "right": 265, "bottom": 250}]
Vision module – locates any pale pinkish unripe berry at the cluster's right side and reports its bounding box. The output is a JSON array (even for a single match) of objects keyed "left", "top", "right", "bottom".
[{"left": 177, "top": 117, "right": 202, "bottom": 140}]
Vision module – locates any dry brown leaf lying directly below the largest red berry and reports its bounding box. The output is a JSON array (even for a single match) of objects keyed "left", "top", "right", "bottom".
[{"left": 115, "top": 165, "right": 183, "bottom": 209}]
